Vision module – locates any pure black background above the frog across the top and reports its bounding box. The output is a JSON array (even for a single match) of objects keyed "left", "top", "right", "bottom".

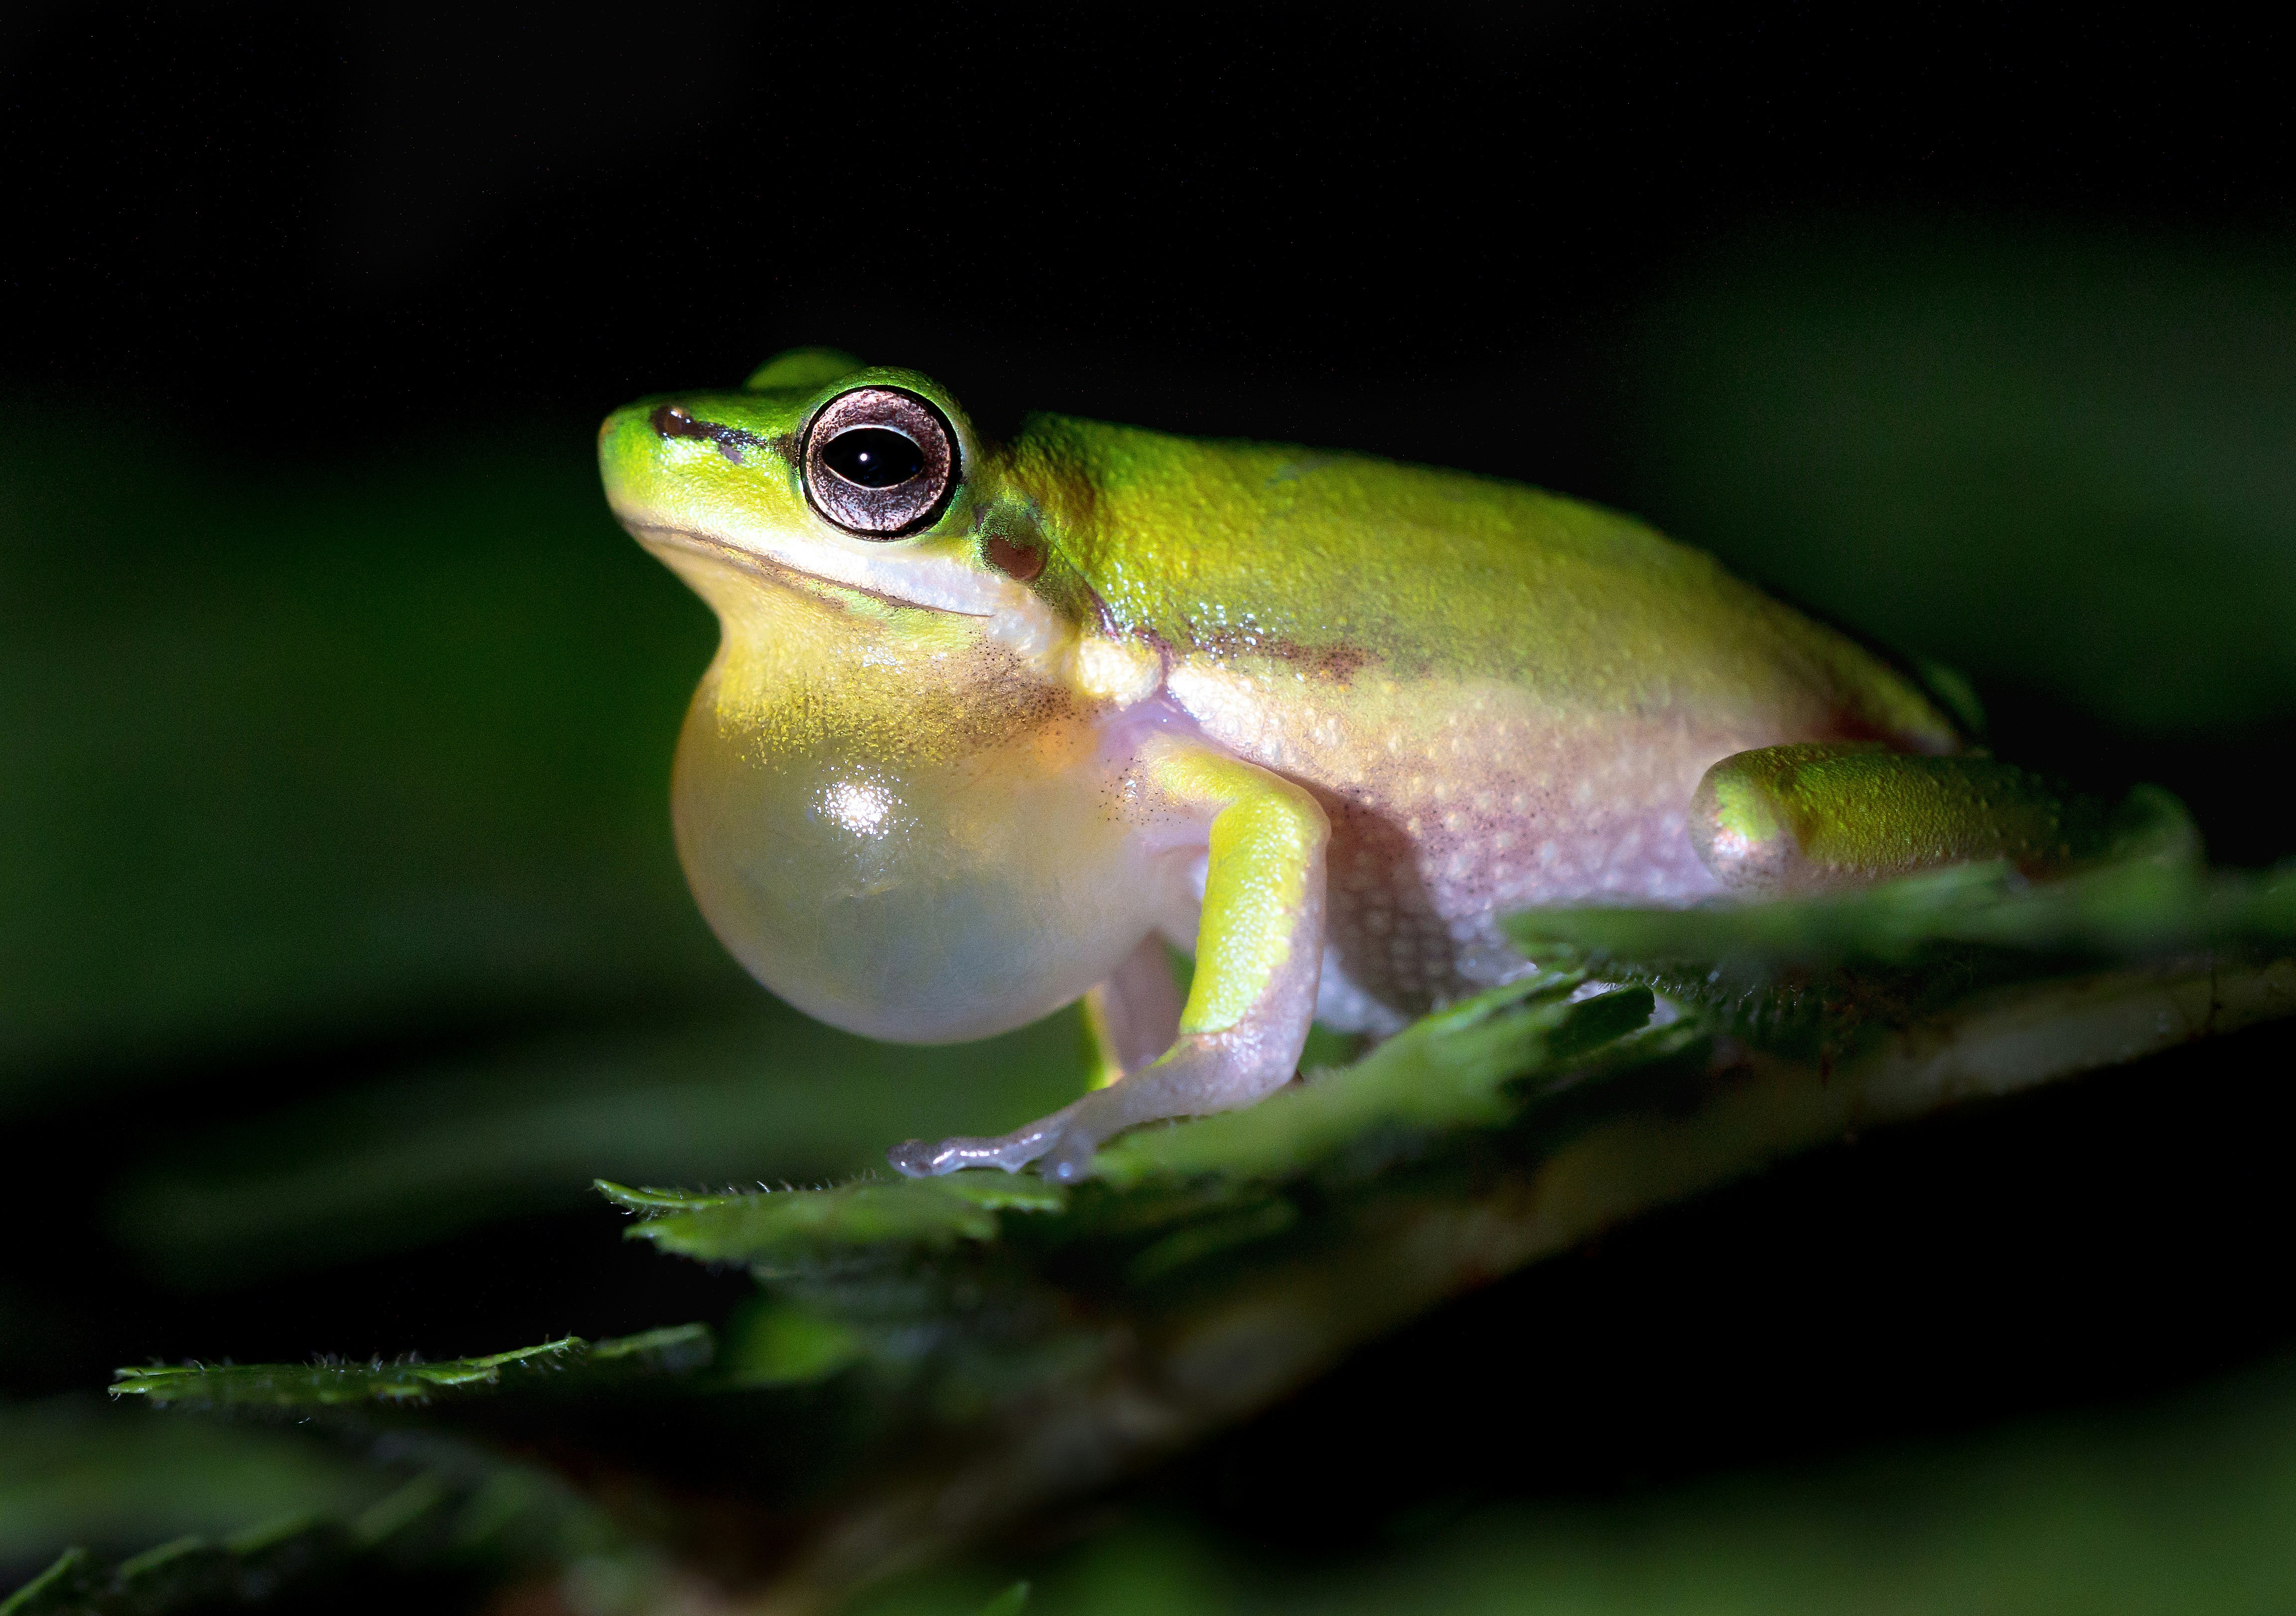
[{"left": 18, "top": 4, "right": 2289, "bottom": 479}]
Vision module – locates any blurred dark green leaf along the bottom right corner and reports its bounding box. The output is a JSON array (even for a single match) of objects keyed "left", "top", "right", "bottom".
[{"left": 852, "top": 1361, "right": 2296, "bottom": 1616}]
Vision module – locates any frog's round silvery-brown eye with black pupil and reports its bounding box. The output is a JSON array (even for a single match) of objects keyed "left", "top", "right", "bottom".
[{"left": 806, "top": 388, "right": 958, "bottom": 540}]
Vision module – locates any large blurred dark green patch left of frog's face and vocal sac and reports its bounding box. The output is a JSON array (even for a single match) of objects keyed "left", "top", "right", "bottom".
[{"left": 0, "top": 409, "right": 725, "bottom": 1113}]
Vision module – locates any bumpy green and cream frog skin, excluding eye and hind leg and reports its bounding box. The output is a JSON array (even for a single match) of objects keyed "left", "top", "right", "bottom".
[{"left": 599, "top": 353, "right": 1984, "bottom": 1173}]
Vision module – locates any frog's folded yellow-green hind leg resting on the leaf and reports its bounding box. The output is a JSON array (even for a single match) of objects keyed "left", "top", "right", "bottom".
[{"left": 1690, "top": 744, "right": 2112, "bottom": 895}]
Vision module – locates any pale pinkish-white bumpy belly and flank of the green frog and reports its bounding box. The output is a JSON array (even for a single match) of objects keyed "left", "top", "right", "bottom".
[{"left": 1175, "top": 680, "right": 1871, "bottom": 1030}]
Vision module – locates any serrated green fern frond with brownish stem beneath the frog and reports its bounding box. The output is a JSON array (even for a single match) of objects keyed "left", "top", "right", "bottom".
[{"left": 81, "top": 941, "right": 2296, "bottom": 1591}]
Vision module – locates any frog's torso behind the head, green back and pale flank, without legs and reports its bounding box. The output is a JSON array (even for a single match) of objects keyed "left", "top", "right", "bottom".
[{"left": 1015, "top": 418, "right": 1956, "bottom": 1012}]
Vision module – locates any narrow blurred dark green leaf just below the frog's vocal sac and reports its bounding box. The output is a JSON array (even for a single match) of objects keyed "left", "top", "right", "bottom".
[{"left": 113, "top": 1005, "right": 1086, "bottom": 1286}]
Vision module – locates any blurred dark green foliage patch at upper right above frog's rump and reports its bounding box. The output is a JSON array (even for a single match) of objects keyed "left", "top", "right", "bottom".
[{"left": 1628, "top": 218, "right": 2296, "bottom": 732}]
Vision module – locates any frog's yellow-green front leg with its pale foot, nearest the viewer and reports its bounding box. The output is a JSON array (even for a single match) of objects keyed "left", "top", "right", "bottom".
[{"left": 888, "top": 737, "right": 1332, "bottom": 1180}]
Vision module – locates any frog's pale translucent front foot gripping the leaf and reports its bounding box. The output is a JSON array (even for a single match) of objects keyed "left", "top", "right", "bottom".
[{"left": 886, "top": 1028, "right": 1299, "bottom": 1184}]
